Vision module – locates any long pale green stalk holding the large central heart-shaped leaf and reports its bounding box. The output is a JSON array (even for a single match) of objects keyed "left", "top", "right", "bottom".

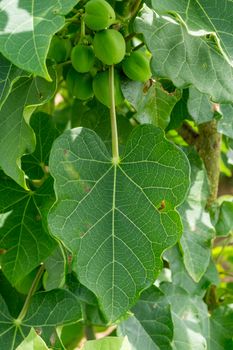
[{"left": 109, "top": 65, "right": 119, "bottom": 164}]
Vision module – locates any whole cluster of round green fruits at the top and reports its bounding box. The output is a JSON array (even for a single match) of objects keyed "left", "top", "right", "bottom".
[{"left": 49, "top": 0, "right": 151, "bottom": 107}]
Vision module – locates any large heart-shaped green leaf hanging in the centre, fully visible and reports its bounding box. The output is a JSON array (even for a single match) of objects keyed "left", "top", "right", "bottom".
[{"left": 48, "top": 125, "right": 189, "bottom": 322}]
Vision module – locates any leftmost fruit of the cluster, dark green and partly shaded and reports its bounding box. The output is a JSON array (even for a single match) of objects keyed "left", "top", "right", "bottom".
[{"left": 48, "top": 35, "right": 72, "bottom": 63}]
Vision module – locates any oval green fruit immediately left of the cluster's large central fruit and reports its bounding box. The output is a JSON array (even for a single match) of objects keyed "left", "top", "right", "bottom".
[{"left": 71, "top": 44, "right": 95, "bottom": 73}]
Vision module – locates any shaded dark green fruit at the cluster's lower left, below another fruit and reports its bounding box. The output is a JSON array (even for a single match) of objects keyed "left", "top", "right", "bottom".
[{"left": 66, "top": 68, "right": 93, "bottom": 100}]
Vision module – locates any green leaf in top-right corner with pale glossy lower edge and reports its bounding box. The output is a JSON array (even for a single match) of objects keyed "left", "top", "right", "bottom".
[{"left": 152, "top": 0, "right": 233, "bottom": 64}]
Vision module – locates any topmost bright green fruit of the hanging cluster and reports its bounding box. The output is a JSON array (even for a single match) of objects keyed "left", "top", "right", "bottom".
[{"left": 84, "top": 0, "right": 116, "bottom": 30}]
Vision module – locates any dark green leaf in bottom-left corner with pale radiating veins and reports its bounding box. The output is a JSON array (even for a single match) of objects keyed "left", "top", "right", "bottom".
[{"left": 0, "top": 289, "right": 81, "bottom": 349}]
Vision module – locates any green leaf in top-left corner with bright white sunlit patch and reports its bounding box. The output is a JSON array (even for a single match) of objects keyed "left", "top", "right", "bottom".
[{"left": 0, "top": 0, "right": 78, "bottom": 80}]
